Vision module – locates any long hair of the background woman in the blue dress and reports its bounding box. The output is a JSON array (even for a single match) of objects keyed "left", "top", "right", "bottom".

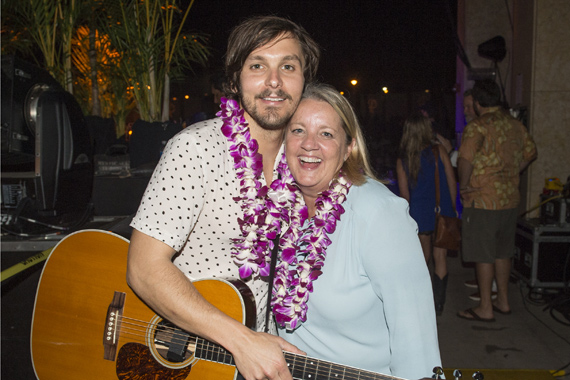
[{"left": 400, "top": 115, "right": 433, "bottom": 184}]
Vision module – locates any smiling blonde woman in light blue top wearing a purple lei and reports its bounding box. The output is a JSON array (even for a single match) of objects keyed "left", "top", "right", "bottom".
[{"left": 270, "top": 84, "right": 440, "bottom": 379}]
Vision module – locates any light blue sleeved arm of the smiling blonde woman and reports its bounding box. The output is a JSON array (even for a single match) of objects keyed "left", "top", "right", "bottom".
[{"left": 357, "top": 197, "right": 441, "bottom": 379}]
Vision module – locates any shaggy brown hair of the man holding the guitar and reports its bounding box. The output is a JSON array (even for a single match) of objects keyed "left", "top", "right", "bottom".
[{"left": 224, "top": 16, "right": 320, "bottom": 99}]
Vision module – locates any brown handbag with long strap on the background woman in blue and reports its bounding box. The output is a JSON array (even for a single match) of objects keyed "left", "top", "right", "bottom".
[{"left": 433, "top": 146, "right": 461, "bottom": 251}]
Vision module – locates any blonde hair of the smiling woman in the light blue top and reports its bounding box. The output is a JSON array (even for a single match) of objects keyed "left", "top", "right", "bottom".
[{"left": 301, "top": 83, "right": 376, "bottom": 186}]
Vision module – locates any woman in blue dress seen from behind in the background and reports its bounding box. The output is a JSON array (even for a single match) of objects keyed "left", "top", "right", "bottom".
[{"left": 396, "top": 115, "right": 457, "bottom": 315}]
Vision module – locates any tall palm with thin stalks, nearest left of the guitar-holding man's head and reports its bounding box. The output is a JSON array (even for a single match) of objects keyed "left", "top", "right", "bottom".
[{"left": 100, "top": 0, "right": 209, "bottom": 122}]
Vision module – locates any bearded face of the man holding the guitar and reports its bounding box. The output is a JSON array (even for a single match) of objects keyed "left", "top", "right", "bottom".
[{"left": 239, "top": 38, "right": 305, "bottom": 130}]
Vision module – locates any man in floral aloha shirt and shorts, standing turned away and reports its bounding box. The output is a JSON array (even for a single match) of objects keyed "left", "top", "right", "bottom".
[{"left": 458, "top": 80, "right": 537, "bottom": 322}]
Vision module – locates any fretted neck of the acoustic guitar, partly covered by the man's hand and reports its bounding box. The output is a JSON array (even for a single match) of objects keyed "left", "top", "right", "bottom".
[{"left": 194, "top": 338, "right": 404, "bottom": 380}]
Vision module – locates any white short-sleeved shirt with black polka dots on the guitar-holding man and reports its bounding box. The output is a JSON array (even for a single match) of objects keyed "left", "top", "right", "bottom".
[{"left": 131, "top": 118, "right": 280, "bottom": 331}]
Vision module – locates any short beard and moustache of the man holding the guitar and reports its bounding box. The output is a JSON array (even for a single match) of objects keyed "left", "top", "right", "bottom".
[{"left": 241, "top": 90, "right": 296, "bottom": 131}]
